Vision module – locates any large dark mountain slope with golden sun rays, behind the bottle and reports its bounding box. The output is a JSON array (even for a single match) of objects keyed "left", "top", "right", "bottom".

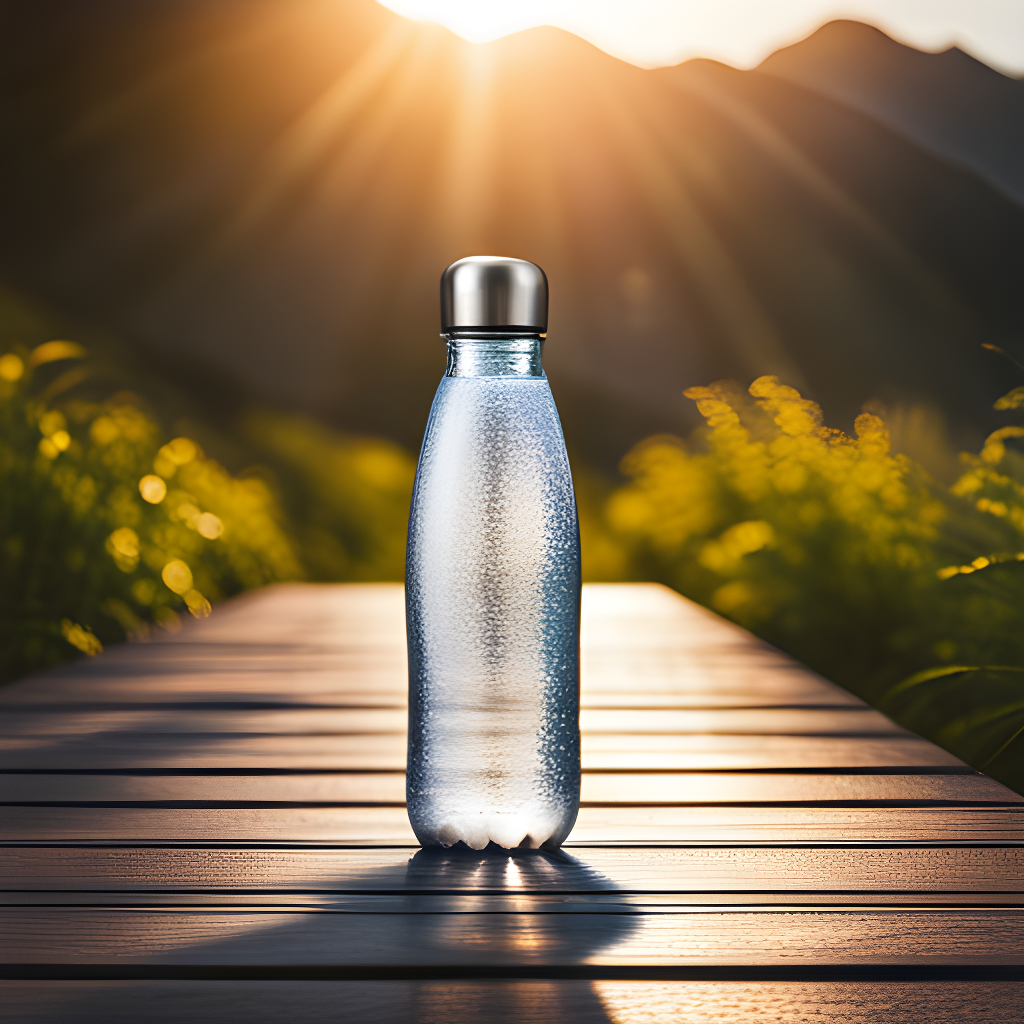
[{"left": 0, "top": 0, "right": 1024, "bottom": 466}]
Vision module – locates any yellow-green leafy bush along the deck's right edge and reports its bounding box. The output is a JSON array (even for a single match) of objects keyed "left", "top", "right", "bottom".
[{"left": 604, "top": 377, "right": 1024, "bottom": 788}]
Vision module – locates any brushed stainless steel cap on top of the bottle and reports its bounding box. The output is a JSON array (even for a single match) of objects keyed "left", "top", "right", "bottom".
[{"left": 441, "top": 256, "right": 548, "bottom": 334}]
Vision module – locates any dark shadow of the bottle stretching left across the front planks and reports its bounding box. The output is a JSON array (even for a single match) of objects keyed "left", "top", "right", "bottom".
[{"left": 32, "top": 844, "right": 640, "bottom": 1024}]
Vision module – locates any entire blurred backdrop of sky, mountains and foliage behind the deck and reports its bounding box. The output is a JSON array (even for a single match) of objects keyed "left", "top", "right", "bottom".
[{"left": 0, "top": 0, "right": 1024, "bottom": 790}]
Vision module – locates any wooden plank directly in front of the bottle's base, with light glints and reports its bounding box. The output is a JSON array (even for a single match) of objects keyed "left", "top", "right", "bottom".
[{"left": 0, "top": 846, "right": 1024, "bottom": 895}]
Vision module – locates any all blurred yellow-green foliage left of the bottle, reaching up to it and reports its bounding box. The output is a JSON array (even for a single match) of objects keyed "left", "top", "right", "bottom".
[{"left": 0, "top": 285, "right": 416, "bottom": 681}]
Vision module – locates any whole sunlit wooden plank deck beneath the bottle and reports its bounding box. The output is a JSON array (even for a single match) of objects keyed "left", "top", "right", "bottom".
[{"left": 0, "top": 585, "right": 1024, "bottom": 1024}]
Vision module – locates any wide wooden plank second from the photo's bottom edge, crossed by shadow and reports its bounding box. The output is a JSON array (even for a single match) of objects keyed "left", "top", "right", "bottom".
[{"left": 0, "top": 909, "right": 1024, "bottom": 968}]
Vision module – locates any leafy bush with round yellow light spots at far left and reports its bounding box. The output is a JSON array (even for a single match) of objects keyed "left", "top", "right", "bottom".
[{"left": 0, "top": 341, "right": 303, "bottom": 679}]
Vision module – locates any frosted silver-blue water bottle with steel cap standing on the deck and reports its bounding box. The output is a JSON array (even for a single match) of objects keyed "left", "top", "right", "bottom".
[{"left": 406, "top": 256, "right": 580, "bottom": 850}]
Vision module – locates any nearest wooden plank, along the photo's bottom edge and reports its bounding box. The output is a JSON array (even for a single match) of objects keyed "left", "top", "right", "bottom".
[{"left": 0, "top": 979, "right": 1024, "bottom": 1024}]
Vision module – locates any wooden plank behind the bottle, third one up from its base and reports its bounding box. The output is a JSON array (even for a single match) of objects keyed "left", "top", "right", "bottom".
[{"left": 0, "top": 733, "right": 967, "bottom": 771}]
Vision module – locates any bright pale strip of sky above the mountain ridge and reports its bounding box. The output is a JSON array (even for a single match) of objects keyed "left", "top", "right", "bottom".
[{"left": 381, "top": 0, "right": 1024, "bottom": 76}]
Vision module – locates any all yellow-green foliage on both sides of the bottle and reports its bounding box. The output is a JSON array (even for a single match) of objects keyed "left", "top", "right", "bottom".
[{"left": 0, "top": 276, "right": 1024, "bottom": 791}]
